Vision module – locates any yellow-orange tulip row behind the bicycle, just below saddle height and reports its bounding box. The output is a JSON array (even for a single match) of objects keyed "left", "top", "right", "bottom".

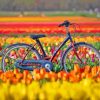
[{"left": 0, "top": 36, "right": 100, "bottom": 46}]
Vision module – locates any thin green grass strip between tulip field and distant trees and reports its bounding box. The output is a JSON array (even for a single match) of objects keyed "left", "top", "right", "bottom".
[{"left": 0, "top": 11, "right": 100, "bottom": 17}]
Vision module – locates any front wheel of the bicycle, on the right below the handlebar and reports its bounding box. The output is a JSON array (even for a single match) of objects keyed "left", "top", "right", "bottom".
[{"left": 62, "top": 42, "right": 100, "bottom": 72}]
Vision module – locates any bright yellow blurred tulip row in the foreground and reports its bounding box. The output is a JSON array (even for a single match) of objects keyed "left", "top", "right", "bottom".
[{"left": 0, "top": 79, "right": 100, "bottom": 100}]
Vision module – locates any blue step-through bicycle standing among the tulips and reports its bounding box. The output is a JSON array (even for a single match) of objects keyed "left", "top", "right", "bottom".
[{"left": 1, "top": 21, "right": 100, "bottom": 72}]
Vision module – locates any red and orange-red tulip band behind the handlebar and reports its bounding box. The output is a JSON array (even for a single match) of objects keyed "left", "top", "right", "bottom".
[{"left": 0, "top": 22, "right": 100, "bottom": 34}]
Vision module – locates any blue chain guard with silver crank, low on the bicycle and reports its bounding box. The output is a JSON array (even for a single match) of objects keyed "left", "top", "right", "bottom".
[{"left": 15, "top": 60, "right": 53, "bottom": 71}]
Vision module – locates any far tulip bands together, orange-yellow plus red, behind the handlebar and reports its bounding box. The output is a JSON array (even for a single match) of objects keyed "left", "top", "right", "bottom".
[{"left": 0, "top": 16, "right": 100, "bottom": 34}]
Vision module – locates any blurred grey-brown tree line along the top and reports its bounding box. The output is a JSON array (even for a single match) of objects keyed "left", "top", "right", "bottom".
[{"left": 0, "top": 0, "right": 100, "bottom": 11}]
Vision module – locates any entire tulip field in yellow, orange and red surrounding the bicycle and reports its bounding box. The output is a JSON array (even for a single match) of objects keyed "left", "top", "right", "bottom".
[{"left": 0, "top": 16, "right": 100, "bottom": 100}]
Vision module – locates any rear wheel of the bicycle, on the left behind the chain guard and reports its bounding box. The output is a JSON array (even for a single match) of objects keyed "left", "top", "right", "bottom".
[{"left": 1, "top": 43, "right": 40, "bottom": 72}]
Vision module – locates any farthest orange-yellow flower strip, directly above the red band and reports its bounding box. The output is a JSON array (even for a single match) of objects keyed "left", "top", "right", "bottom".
[{"left": 0, "top": 16, "right": 100, "bottom": 23}]
